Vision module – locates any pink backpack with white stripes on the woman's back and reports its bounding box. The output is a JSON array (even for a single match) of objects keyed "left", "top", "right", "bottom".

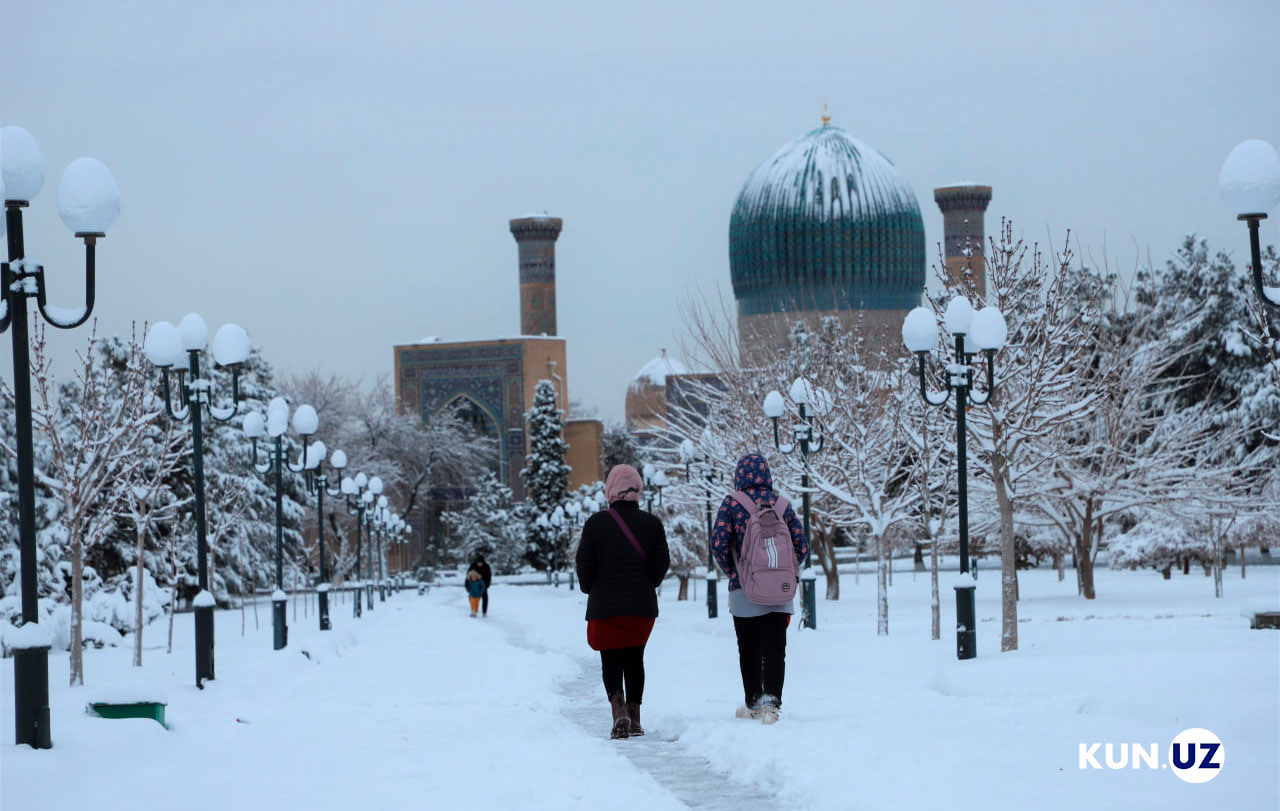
[{"left": 733, "top": 490, "right": 800, "bottom": 605}]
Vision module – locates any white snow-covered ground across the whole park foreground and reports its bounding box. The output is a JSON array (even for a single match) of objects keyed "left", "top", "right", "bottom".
[{"left": 0, "top": 562, "right": 1280, "bottom": 811}]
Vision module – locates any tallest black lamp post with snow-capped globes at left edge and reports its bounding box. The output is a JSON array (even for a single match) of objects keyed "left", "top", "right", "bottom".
[{"left": 0, "top": 127, "right": 120, "bottom": 750}]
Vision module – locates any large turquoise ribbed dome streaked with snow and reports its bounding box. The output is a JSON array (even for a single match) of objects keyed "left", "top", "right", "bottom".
[{"left": 728, "top": 127, "right": 924, "bottom": 315}]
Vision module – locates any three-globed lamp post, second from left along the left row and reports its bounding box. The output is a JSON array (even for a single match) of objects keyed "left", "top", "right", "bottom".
[{"left": 143, "top": 312, "right": 252, "bottom": 689}]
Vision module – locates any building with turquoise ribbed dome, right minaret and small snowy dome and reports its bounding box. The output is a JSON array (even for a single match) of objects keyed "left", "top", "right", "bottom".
[{"left": 626, "top": 115, "right": 991, "bottom": 432}]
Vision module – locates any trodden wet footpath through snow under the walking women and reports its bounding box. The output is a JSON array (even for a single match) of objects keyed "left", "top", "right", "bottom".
[{"left": 498, "top": 611, "right": 778, "bottom": 811}]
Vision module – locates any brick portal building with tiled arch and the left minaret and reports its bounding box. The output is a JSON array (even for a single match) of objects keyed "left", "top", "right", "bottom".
[{"left": 394, "top": 214, "right": 604, "bottom": 550}]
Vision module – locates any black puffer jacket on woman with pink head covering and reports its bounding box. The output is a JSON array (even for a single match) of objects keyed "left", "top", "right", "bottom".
[{"left": 577, "top": 501, "right": 671, "bottom": 619}]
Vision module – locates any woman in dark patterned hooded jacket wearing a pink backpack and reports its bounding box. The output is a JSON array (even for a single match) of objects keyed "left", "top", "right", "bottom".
[{"left": 712, "top": 453, "right": 809, "bottom": 724}]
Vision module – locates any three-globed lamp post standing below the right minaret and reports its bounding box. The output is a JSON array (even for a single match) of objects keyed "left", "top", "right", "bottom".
[{"left": 902, "top": 295, "right": 1009, "bottom": 659}]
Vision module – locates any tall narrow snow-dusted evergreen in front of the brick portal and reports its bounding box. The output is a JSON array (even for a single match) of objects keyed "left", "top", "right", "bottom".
[{"left": 520, "top": 380, "right": 570, "bottom": 569}]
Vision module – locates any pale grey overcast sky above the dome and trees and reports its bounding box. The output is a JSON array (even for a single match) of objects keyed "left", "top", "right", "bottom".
[{"left": 0, "top": 0, "right": 1280, "bottom": 418}]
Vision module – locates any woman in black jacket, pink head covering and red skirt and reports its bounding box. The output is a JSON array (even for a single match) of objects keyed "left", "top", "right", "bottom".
[{"left": 576, "top": 464, "right": 671, "bottom": 738}]
